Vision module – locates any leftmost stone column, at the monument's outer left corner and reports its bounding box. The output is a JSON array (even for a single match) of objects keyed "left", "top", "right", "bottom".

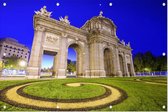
[{"left": 27, "top": 26, "right": 45, "bottom": 78}]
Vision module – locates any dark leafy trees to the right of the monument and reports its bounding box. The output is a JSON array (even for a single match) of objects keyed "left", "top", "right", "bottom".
[{"left": 134, "top": 51, "right": 167, "bottom": 72}]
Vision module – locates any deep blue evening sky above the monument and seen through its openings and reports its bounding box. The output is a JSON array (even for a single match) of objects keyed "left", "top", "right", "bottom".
[{"left": 0, "top": 0, "right": 167, "bottom": 66}]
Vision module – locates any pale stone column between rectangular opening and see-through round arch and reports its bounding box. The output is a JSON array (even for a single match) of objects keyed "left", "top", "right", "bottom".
[{"left": 57, "top": 36, "right": 68, "bottom": 78}]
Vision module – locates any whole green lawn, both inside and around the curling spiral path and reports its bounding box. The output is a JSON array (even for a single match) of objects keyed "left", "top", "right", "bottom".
[{"left": 0, "top": 77, "right": 167, "bottom": 111}]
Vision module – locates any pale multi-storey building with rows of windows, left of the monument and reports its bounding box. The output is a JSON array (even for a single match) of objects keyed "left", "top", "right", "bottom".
[{"left": 0, "top": 38, "right": 30, "bottom": 62}]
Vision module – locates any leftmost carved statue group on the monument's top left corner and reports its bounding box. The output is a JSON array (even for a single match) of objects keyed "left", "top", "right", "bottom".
[{"left": 35, "top": 6, "right": 52, "bottom": 17}]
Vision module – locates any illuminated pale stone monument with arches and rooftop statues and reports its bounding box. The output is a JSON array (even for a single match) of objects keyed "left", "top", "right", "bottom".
[{"left": 27, "top": 6, "right": 135, "bottom": 78}]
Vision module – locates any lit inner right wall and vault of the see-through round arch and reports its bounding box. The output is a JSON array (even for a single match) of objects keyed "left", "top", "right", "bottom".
[{"left": 67, "top": 43, "right": 83, "bottom": 77}]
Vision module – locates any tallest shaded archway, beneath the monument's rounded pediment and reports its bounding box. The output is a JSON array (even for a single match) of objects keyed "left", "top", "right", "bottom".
[{"left": 104, "top": 48, "right": 114, "bottom": 77}]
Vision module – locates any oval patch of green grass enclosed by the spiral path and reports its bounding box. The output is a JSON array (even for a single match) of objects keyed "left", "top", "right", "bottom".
[{"left": 23, "top": 80, "right": 105, "bottom": 99}]
